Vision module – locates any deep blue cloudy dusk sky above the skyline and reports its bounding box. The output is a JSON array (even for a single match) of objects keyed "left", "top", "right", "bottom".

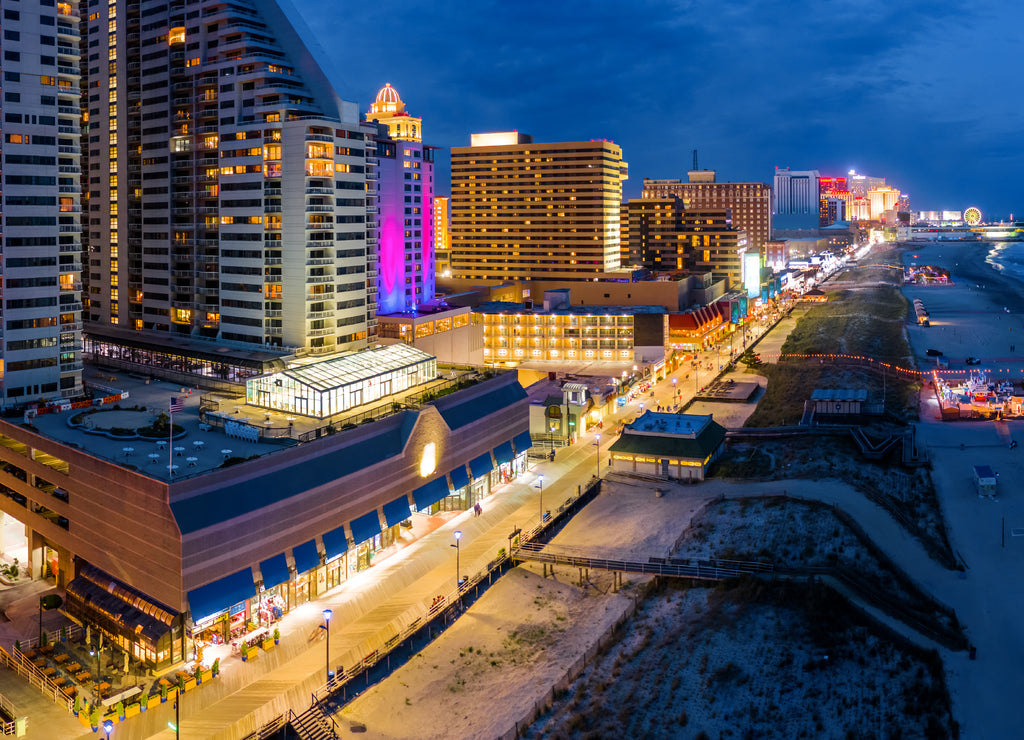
[{"left": 294, "top": 0, "right": 1024, "bottom": 219}]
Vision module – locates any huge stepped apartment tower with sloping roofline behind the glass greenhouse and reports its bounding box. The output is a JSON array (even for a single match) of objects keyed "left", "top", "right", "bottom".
[{"left": 81, "top": 0, "right": 376, "bottom": 354}]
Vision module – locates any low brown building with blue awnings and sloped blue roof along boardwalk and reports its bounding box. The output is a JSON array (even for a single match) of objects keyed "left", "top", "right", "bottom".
[{"left": 0, "top": 370, "right": 530, "bottom": 668}]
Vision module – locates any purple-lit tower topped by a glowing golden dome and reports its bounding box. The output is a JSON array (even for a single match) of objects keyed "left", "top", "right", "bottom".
[{"left": 367, "top": 85, "right": 434, "bottom": 314}]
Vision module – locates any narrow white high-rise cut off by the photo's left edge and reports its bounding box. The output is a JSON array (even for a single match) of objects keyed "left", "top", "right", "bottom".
[{"left": 0, "top": 0, "right": 82, "bottom": 405}]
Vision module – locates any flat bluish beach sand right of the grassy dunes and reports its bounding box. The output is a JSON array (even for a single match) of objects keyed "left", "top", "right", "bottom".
[{"left": 903, "top": 243, "right": 1024, "bottom": 738}]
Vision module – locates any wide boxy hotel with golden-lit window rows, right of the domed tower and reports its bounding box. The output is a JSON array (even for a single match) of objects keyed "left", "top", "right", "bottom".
[{"left": 452, "top": 132, "right": 628, "bottom": 281}]
